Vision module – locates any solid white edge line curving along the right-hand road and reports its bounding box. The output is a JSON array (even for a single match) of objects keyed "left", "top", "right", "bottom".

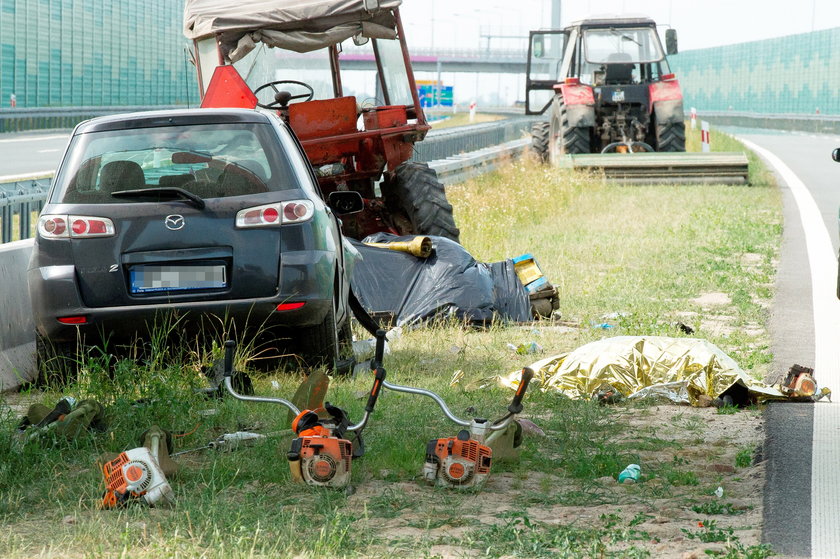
[{"left": 741, "top": 139, "right": 840, "bottom": 558}]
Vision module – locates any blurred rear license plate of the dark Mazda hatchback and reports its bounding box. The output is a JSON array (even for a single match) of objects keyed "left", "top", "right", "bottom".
[{"left": 129, "top": 264, "right": 227, "bottom": 293}]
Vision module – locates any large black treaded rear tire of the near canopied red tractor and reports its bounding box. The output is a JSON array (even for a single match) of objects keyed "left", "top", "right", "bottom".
[{"left": 386, "top": 162, "right": 461, "bottom": 243}]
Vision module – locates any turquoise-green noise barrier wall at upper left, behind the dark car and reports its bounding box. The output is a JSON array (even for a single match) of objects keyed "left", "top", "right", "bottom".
[{"left": 0, "top": 0, "right": 198, "bottom": 109}]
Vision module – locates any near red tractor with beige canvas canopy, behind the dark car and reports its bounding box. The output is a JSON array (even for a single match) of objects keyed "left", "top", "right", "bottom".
[{"left": 184, "top": 0, "right": 459, "bottom": 241}]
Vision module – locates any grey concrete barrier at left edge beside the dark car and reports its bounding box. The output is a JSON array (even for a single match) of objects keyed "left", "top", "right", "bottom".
[{"left": 0, "top": 239, "right": 37, "bottom": 391}]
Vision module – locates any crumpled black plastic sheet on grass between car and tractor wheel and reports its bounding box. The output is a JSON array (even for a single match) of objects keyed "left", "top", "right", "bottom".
[{"left": 351, "top": 233, "right": 531, "bottom": 326}]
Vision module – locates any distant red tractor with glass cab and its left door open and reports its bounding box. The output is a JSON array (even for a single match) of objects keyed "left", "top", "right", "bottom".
[{"left": 525, "top": 17, "right": 685, "bottom": 163}]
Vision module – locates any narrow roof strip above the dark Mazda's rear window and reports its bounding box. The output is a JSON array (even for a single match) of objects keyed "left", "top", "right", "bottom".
[{"left": 75, "top": 109, "right": 282, "bottom": 134}]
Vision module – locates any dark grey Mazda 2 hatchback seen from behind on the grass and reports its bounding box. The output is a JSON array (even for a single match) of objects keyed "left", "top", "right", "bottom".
[{"left": 29, "top": 109, "right": 361, "bottom": 374}]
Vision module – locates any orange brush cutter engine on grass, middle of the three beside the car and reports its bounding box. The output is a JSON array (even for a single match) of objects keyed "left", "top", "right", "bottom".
[{"left": 287, "top": 410, "right": 353, "bottom": 487}]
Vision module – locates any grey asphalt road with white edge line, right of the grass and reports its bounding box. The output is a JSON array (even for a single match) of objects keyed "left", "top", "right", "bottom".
[{"left": 733, "top": 130, "right": 840, "bottom": 557}]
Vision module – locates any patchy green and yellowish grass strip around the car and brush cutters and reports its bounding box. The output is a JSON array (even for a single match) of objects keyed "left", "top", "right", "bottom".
[{"left": 0, "top": 150, "right": 781, "bottom": 558}]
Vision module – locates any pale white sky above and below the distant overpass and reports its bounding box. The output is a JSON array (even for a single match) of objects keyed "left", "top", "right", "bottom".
[{"left": 388, "top": 0, "right": 840, "bottom": 107}]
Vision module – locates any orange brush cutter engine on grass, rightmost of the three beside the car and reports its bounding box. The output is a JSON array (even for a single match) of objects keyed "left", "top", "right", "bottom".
[{"left": 423, "top": 429, "right": 493, "bottom": 487}]
